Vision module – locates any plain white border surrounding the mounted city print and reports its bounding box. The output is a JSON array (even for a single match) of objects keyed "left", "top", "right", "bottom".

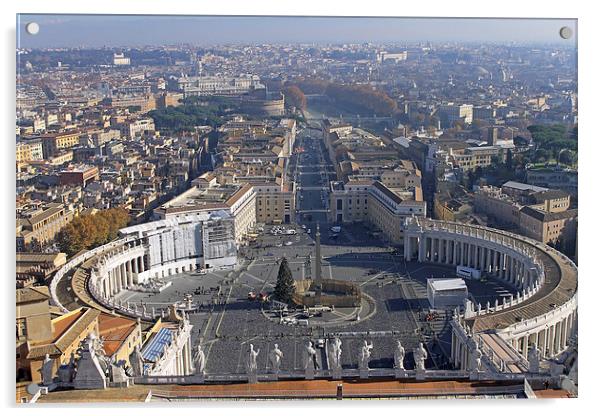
[{"left": 0, "top": 0, "right": 602, "bottom": 415}]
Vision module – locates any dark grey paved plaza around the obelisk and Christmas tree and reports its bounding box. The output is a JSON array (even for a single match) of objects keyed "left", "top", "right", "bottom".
[{"left": 113, "top": 219, "right": 509, "bottom": 374}]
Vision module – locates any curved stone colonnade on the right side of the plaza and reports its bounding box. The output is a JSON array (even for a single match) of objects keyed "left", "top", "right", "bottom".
[{"left": 404, "top": 218, "right": 577, "bottom": 371}]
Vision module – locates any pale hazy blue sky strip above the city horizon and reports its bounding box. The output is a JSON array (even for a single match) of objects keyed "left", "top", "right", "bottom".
[{"left": 17, "top": 15, "right": 576, "bottom": 48}]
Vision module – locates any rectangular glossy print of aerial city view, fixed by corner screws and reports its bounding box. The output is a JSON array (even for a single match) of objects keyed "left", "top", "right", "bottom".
[{"left": 11, "top": 15, "right": 584, "bottom": 404}]
